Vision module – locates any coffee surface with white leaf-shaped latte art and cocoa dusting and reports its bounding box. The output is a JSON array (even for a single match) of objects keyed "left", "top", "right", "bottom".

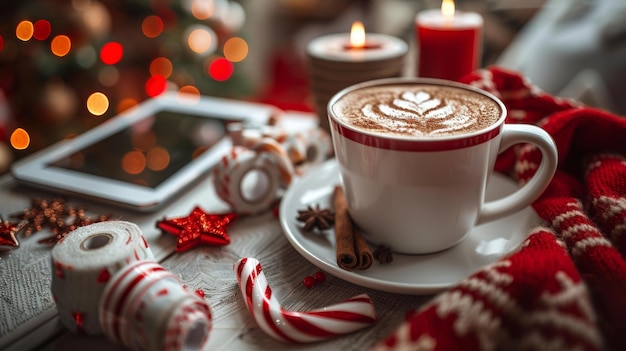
[{"left": 332, "top": 84, "right": 502, "bottom": 137}]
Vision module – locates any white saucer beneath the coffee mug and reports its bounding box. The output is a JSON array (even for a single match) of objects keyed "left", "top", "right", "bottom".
[{"left": 279, "top": 159, "right": 540, "bottom": 295}]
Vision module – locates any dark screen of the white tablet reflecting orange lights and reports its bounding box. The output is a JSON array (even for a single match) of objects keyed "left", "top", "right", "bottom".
[{"left": 49, "top": 110, "right": 232, "bottom": 188}]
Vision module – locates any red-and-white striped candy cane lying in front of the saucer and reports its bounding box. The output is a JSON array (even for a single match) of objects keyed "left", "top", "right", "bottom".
[{"left": 233, "top": 258, "right": 377, "bottom": 343}]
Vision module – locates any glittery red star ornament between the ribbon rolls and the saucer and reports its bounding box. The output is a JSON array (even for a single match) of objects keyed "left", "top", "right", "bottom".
[{"left": 157, "top": 207, "right": 237, "bottom": 252}]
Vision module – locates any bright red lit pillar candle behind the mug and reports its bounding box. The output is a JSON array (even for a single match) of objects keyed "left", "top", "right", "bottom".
[{"left": 415, "top": 0, "right": 483, "bottom": 80}]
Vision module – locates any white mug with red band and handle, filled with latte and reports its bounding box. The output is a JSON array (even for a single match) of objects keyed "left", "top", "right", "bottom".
[{"left": 328, "top": 78, "right": 557, "bottom": 254}]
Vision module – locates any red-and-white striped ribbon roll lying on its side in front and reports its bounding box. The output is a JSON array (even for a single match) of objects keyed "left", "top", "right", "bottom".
[{"left": 99, "top": 261, "right": 212, "bottom": 350}]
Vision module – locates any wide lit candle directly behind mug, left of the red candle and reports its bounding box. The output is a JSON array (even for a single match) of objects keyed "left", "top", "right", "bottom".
[{"left": 307, "top": 33, "right": 408, "bottom": 131}]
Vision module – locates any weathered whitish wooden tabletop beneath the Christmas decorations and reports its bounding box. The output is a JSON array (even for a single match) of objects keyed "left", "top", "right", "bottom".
[{"left": 0, "top": 117, "right": 432, "bottom": 351}]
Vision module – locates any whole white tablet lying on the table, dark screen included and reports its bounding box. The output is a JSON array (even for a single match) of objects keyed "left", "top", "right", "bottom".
[{"left": 11, "top": 93, "right": 275, "bottom": 211}]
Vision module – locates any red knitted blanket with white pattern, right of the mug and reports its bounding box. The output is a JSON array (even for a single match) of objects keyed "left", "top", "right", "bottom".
[{"left": 373, "top": 67, "right": 626, "bottom": 350}]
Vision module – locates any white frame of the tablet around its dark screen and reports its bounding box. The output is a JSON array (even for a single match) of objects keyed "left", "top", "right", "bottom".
[{"left": 11, "top": 92, "right": 275, "bottom": 211}]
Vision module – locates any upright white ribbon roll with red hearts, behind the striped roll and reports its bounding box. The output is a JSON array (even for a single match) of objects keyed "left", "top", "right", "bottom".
[{"left": 51, "top": 221, "right": 154, "bottom": 335}]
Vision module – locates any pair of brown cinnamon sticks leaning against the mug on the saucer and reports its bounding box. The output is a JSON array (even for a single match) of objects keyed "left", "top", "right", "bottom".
[{"left": 332, "top": 186, "right": 374, "bottom": 270}]
